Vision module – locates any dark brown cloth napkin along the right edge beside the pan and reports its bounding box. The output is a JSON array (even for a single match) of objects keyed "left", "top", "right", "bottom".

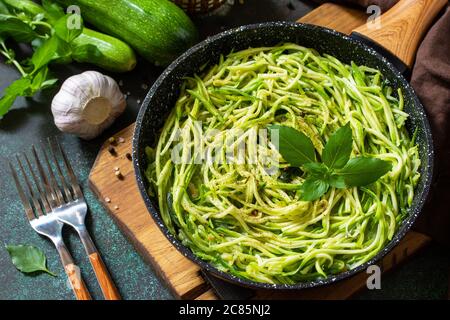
[{"left": 315, "top": 0, "right": 450, "bottom": 246}]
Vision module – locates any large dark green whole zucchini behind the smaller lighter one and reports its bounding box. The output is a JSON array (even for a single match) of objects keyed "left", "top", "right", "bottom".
[{"left": 57, "top": 0, "right": 197, "bottom": 66}]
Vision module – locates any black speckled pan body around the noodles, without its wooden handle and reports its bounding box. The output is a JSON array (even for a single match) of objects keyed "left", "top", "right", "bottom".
[{"left": 133, "top": 0, "right": 442, "bottom": 289}]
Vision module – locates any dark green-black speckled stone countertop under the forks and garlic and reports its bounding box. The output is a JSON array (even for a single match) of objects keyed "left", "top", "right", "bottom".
[{"left": 0, "top": 0, "right": 450, "bottom": 299}]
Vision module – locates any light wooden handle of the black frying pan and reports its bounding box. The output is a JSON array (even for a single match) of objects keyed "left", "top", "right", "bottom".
[{"left": 353, "top": 0, "right": 447, "bottom": 68}]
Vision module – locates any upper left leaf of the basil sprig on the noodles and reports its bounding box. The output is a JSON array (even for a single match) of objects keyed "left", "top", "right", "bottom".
[{"left": 269, "top": 125, "right": 316, "bottom": 167}]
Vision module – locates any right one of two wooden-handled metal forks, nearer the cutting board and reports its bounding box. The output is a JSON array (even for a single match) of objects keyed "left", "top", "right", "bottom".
[{"left": 47, "top": 139, "right": 121, "bottom": 300}]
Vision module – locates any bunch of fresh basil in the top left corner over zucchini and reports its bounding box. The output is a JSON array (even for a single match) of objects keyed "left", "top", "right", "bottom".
[{"left": 0, "top": 0, "right": 101, "bottom": 119}]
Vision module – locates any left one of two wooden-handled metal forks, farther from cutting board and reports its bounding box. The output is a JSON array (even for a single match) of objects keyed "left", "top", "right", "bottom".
[{"left": 9, "top": 150, "right": 91, "bottom": 300}]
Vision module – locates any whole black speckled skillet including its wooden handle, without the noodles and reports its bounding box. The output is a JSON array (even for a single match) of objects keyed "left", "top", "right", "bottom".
[{"left": 133, "top": 0, "right": 447, "bottom": 289}]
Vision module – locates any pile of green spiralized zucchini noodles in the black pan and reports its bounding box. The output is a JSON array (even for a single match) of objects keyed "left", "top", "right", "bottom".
[{"left": 146, "top": 43, "right": 420, "bottom": 284}]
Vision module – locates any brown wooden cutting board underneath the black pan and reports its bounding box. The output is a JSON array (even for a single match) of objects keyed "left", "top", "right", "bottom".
[{"left": 89, "top": 4, "right": 430, "bottom": 300}]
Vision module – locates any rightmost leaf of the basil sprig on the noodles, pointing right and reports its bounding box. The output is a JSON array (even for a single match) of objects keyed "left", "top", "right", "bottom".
[{"left": 337, "top": 157, "right": 392, "bottom": 187}]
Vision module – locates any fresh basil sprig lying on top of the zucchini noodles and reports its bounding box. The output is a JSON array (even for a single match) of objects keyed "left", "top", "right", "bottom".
[{"left": 270, "top": 124, "right": 392, "bottom": 201}]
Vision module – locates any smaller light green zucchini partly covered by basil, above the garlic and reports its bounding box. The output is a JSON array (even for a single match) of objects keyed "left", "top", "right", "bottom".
[{"left": 0, "top": 0, "right": 136, "bottom": 72}]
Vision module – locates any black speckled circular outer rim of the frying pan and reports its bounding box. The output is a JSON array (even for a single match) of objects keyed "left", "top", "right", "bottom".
[{"left": 132, "top": 21, "right": 434, "bottom": 290}]
